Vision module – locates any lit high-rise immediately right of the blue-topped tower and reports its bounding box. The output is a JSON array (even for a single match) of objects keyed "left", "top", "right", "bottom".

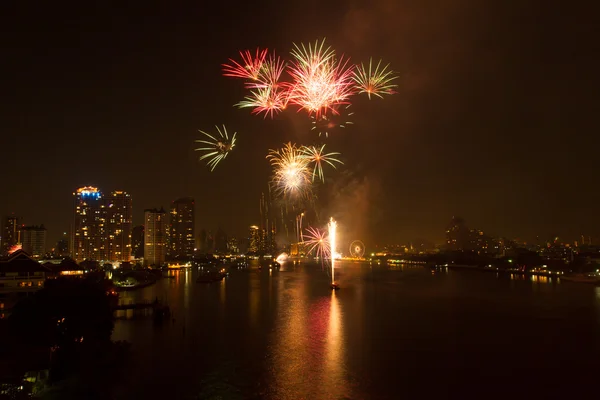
[{"left": 105, "top": 191, "right": 132, "bottom": 261}]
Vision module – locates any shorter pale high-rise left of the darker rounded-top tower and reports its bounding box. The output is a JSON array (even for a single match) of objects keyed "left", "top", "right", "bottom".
[{"left": 144, "top": 207, "right": 169, "bottom": 266}]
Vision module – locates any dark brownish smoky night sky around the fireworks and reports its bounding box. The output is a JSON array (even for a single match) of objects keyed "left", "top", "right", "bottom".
[{"left": 0, "top": 0, "right": 600, "bottom": 246}]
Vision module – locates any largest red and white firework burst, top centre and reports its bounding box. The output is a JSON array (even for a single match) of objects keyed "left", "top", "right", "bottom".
[{"left": 288, "top": 40, "right": 354, "bottom": 117}]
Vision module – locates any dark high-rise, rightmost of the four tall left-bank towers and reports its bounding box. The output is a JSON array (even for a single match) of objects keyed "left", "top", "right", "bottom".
[{"left": 169, "top": 197, "right": 196, "bottom": 258}]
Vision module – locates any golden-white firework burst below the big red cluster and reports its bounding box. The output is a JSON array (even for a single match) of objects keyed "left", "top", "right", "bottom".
[{"left": 267, "top": 143, "right": 311, "bottom": 196}]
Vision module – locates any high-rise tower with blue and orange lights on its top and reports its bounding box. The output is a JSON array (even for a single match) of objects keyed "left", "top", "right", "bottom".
[{"left": 71, "top": 186, "right": 108, "bottom": 263}]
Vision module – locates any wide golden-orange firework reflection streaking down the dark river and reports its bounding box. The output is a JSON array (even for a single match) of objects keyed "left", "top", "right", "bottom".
[{"left": 269, "top": 272, "right": 349, "bottom": 400}]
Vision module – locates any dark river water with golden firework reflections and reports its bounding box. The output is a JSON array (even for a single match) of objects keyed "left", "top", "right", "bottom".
[{"left": 113, "top": 263, "right": 600, "bottom": 400}]
